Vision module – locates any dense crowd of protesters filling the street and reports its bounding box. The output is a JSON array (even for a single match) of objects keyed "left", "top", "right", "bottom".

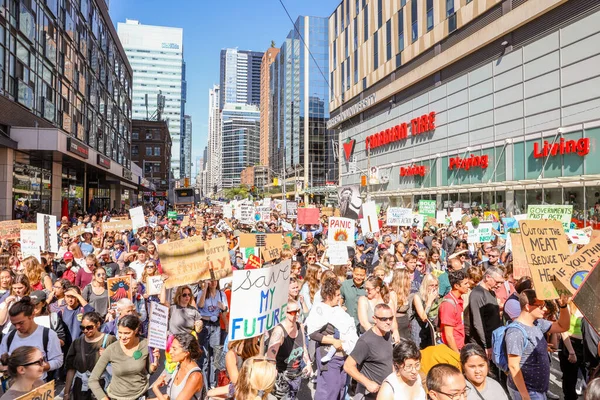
[{"left": 0, "top": 200, "right": 600, "bottom": 400}]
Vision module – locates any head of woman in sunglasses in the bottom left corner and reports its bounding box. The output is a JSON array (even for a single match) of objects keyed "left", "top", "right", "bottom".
[{"left": 0, "top": 346, "right": 45, "bottom": 400}]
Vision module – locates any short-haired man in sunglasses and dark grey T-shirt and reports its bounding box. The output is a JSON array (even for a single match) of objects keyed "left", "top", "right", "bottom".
[{"left": 344, "top": 303, "right": 395, "bottom": 400}]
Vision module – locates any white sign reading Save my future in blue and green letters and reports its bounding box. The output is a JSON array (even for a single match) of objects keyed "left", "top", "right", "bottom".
[{"left": 229, "top": 260, "right": 292, "bottom": 342}]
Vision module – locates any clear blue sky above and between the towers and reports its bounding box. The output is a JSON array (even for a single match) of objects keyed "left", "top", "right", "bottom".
[{"left": 110, "top": 0, "right": 340, "bottom": 170}]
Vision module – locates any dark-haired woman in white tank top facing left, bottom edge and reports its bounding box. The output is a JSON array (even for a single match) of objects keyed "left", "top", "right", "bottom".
[{"left": 152, "top": 333, "right": 206, "bottom": 400}]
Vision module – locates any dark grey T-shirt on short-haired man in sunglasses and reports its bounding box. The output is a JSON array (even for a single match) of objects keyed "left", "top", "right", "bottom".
[{"left": 350, "top": 329, "right": 393, "bottom": 385}]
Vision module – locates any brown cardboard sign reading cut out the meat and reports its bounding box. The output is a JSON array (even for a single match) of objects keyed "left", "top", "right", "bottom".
[{"left": 519, "top": 220, "right": 569, "bottom": 300}]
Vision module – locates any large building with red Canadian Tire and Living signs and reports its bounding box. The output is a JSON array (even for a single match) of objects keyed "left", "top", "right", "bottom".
[{"left": 329, "top": 0, "right": 600, "bottom": 222}]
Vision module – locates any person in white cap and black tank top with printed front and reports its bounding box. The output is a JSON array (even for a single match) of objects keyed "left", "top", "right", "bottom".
[{"left": 267, "top": 302, "right": 312, "bottom": 400}]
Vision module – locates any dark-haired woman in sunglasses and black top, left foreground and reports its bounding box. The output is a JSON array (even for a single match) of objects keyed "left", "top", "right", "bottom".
[{"left": 63, "top": 311, "right": 117, "bottom": 400}]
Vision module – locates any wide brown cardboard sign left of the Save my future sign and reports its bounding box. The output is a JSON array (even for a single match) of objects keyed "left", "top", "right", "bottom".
[{"left": 158, "top": 236, "right": 231, "bottom": 289}]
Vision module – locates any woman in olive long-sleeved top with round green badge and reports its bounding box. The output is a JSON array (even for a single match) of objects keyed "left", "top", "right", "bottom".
[{"left": 88, "top": 315, "right": 160, "bottom": 399}]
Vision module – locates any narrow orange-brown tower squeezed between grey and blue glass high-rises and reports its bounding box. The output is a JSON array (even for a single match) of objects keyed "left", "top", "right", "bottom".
[{"left": 260, "top": 47, "right": 279, "bottom": 166}]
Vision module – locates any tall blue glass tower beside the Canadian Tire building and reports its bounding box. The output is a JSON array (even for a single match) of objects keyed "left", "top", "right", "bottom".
[{"left": 269, "top": 16, "right": 338, "bottom": 200}]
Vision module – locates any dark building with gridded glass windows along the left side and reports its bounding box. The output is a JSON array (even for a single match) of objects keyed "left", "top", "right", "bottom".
[{"left": 0, "top": 0, "right": 145, "bottom": 221}]
